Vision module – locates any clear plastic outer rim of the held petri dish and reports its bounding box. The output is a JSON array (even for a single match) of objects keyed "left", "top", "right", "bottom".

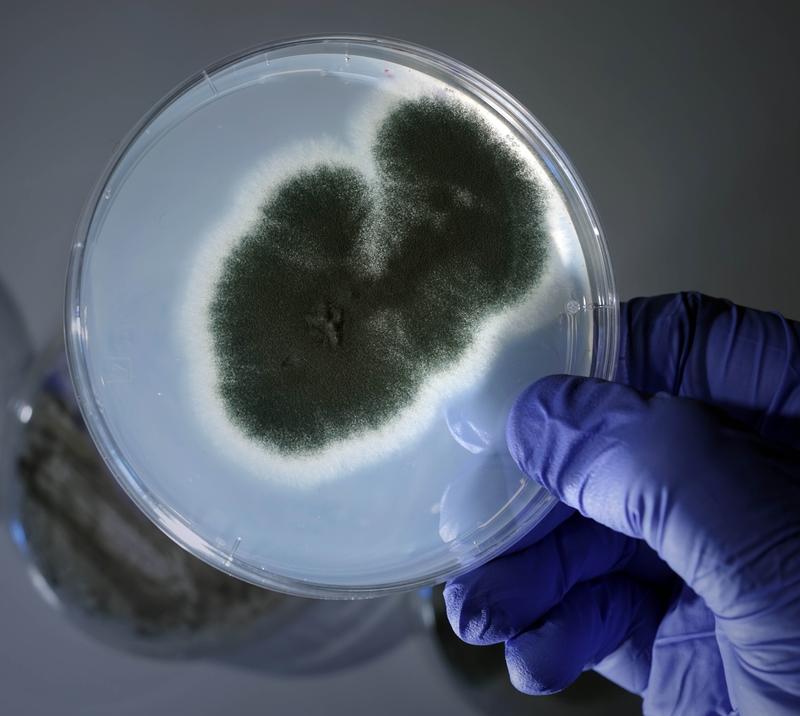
[{"left": 64, "top": 34, "right": 619, "bottom": 599}]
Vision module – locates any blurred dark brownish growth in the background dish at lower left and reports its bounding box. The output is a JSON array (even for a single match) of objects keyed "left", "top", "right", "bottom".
[{"left": 9, "top": 361, "right": 290, "bottom": 657}]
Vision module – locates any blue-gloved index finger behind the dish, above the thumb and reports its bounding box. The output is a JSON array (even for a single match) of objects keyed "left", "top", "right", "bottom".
[{"left": 496, "top": 293, "right": 800, "bottom": 552}]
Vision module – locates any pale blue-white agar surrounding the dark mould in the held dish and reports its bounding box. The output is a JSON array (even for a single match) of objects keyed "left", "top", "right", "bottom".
[{"left": 80, "top": 46, "right": 593, "bottom": 591}]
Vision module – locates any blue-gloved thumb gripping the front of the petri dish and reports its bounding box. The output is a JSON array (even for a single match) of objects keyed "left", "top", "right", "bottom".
[{"left": 508, "top": 376, "right": 800, "bottom": 628}]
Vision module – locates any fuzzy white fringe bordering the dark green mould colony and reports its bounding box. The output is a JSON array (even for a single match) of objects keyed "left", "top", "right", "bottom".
[{"left": 176, "top": 68, "right": 575, "bottom": 488}]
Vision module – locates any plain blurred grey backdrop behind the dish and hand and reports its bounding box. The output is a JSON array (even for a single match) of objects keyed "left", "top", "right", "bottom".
[{"left": 0, "top": 0, "right": 800, "bottom": 716}]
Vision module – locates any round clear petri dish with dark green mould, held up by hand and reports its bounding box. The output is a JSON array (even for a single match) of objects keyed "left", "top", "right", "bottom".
[{"left": 66, "top": 36, "right": 617, "bottom": 598}]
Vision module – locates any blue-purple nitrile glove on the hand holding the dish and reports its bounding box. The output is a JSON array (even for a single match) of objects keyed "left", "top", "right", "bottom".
[{"left": 445, "top": 294, "right": 800, "bottom": 716}]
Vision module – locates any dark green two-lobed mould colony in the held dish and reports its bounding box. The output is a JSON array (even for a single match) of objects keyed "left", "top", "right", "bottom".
[{"left": 210, "top": 97, "right": 547, "bottom": 454}]
